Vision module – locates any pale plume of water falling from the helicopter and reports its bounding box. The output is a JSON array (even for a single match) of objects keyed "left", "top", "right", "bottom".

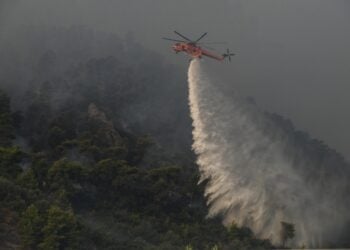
[{"left": 188, "top": 60, "right": 349, "bottom": 247}]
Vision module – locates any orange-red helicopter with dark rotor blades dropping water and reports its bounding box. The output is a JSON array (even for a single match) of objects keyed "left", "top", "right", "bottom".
[{"left": 163, "top": 31, "right": 235, "bottom": 61}]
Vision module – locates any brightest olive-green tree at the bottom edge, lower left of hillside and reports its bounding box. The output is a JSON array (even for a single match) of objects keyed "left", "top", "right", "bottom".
[{"left": 39, "top": 205, "right": 80, "bottom": 250}]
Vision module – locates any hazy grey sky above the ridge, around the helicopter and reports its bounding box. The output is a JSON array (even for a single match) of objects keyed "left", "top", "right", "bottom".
[{"left": 0, "top": 0, "right": 350, "bottom": 159}]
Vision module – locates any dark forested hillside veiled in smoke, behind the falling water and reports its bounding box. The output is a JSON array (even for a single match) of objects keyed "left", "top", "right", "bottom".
[{"left": 0, "top": 27, "right": 347, "bottom": 249}]
